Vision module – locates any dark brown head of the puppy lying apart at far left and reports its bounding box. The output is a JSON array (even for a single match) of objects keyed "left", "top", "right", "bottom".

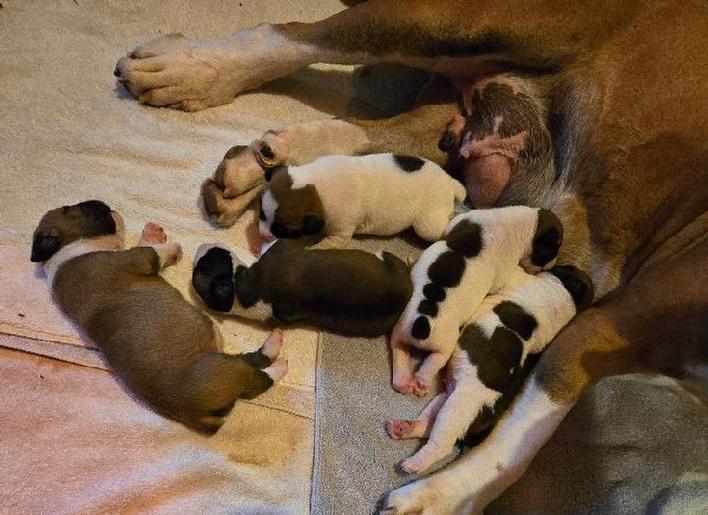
[{"left": 30, "top": 200, "right": 125, "bottom": 263}]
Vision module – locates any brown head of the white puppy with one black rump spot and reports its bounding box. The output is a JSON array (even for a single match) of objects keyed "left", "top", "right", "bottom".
[{"left": 258, "top": 167, "right": 325, "bottom": 243}]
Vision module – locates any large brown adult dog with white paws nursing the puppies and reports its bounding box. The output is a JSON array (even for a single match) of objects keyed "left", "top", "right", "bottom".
[{"left": 116, "top": 0, "right": 708, "bottom": 513}]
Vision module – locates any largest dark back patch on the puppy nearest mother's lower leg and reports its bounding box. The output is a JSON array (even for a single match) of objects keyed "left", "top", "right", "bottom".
[{"left": 458, "top": 325, "right": 523, "bottom": 394}]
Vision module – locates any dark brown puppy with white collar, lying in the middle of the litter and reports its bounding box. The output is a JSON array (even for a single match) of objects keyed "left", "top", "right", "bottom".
[{"left": 192, "top": 240, "right": 413, "bottom": 337}]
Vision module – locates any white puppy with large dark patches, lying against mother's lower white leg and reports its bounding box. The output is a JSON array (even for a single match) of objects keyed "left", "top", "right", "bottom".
[{"left": 386, "top": 266, "right": 593, "bottom": 474}]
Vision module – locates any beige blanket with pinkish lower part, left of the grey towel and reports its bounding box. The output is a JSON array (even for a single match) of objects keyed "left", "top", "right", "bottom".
[{"left": 0, "top": 0, "right": 347, "bottom": 513}]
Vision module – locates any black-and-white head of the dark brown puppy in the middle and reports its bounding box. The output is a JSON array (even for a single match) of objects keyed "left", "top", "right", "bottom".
[{"left": 192, "top": 243, "right": 254, "bottom": 313}]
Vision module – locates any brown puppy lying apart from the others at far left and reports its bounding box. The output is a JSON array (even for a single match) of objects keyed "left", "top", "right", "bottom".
[{"left": 31, "top": 200, "right": 287, "bottom": 433}]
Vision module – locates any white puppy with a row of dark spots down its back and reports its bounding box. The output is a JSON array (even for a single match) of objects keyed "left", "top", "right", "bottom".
[{"left": 391, "top": 206, "right": 563, "bottom": 395}]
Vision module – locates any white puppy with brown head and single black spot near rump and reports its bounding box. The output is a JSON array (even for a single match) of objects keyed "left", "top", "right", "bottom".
[{"left": 259, "top": 154, "right": 466, "bottom": 248}]
